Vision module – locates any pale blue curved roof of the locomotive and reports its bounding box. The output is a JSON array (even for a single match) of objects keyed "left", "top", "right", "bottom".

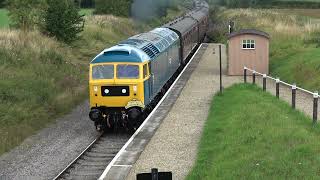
[{"left": 91, "top": 28, "right": 179, "bottom": 64}]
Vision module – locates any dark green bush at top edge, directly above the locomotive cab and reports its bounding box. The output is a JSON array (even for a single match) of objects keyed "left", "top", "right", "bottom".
[{"left": 95, "top": 0, "right": 132, "bottom": 17}]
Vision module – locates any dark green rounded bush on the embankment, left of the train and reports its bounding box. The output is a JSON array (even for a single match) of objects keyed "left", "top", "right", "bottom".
[{"left": 43, "top": 0, "right": 84, "bottom": 43}]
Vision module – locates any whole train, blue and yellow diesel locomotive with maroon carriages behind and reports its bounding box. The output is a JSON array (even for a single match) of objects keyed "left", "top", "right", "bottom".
[{"left": 89, "top": 2, "right": 209, "bottom": 130}]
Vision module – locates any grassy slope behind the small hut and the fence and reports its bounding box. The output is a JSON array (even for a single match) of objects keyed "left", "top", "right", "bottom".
[{"left": 219, "top": 9, "right": 320, "bottom": 91}]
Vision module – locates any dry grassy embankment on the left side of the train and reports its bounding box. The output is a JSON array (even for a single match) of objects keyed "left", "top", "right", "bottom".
[{"left": 0, "top": 7, "right": 185, "bottom": 155}]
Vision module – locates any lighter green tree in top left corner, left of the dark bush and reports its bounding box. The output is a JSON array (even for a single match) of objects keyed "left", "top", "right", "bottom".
[{"left": 6, "top": 0, "right": 46, "bottom": 31}]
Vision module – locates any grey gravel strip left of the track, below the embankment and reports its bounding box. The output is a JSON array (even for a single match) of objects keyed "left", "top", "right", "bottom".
[{"left": 0, "top": 102, "right": 98, "bottom": 180}]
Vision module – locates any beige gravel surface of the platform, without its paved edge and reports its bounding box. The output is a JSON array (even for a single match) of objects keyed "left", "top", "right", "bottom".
[{"left": 127, "top": 44, "right": 241, "bottom": 180}]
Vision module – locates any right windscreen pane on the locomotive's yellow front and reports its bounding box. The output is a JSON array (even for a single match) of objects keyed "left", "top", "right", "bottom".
[{"left": 117, "top": 64, "right": 139, "bottom": 79}]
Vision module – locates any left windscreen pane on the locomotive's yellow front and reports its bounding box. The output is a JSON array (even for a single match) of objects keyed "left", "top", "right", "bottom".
[{"left": 92, "top": 65, "right": 114, "bottom": 79}]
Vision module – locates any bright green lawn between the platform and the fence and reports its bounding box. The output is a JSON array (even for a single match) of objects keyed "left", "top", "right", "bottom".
[{"left": 187, "top": 84, "right": 320, "bottom": 180}]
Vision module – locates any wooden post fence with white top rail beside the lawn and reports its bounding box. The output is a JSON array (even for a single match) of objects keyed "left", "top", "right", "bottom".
[{"left": 243, "top": 67, "right": 319, "bottom": 124}]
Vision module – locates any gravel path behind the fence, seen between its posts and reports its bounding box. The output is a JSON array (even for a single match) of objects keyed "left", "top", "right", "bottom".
[{"left": 247, "top": 76, "right": 320, "bottom": 121}]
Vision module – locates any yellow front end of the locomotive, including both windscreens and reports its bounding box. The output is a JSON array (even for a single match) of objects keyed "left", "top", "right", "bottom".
[{"left": 89, "top": 63, "right": 144, "bottom": 109}]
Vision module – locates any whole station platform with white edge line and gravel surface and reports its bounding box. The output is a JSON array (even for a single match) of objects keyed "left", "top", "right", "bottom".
[{"left": 100, "top": 44, "right": 241, "bottom": 180}]
